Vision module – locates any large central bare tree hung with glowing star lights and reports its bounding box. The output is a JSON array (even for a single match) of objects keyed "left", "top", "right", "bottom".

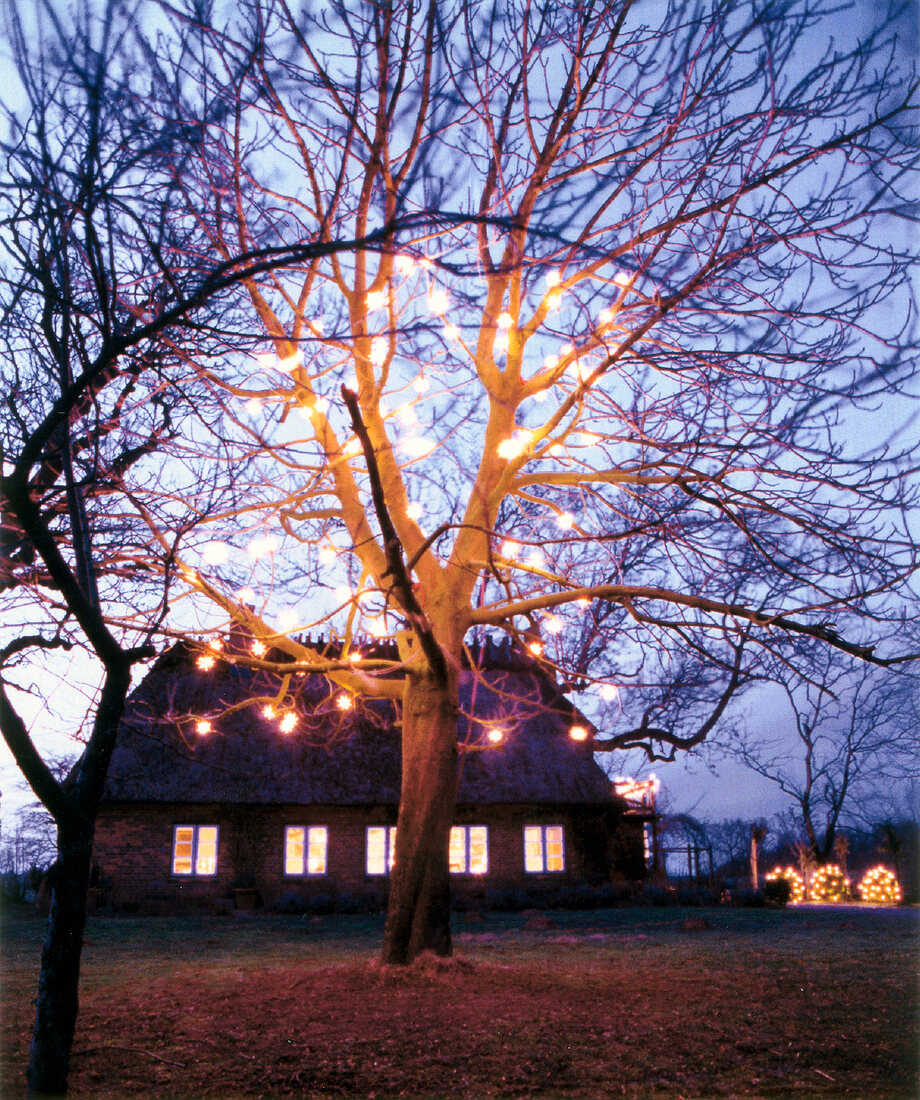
[{"left": 136, "top": 0, "right": 917, "bottom": 963}]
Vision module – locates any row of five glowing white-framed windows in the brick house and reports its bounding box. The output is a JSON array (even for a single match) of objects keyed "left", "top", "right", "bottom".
[{"left": 173, "top": 825, "right": 566, "bottom": 877}]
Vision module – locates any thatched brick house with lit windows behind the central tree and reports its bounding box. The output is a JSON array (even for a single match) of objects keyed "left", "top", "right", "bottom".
[{"left": 94, "top": 645, "right": 648, "bottom": 914}]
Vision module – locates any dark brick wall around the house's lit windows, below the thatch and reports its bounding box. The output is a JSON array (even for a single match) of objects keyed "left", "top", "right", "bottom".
[{"left": 95, "top": 803, "right": 640, "bottom": 915}]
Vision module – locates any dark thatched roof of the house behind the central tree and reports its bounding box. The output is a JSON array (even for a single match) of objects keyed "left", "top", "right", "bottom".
[{"left": 105, "top": 646, "right": 614, "bottom": 806}]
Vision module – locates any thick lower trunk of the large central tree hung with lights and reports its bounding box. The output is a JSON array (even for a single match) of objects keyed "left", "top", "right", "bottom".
[{"left": 381, "top": 660, "right": 458, "bottom": 965}]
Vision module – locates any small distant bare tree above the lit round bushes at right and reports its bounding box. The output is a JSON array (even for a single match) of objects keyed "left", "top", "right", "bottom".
[{"left": 727, "top": 653, "right": 920, "bottom": 866}]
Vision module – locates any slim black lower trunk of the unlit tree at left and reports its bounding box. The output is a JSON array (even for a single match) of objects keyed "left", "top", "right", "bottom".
[{"left": 25, "top": 827, "right": 92, "bottom": 1098}]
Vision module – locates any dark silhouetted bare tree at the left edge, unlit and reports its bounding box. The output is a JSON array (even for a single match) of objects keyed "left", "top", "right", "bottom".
[{"left": 0, "top": 0, "right": 402, "bottom": 1096}]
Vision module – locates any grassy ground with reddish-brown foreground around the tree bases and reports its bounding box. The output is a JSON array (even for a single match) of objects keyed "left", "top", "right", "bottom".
[{"left": 0, "top": 908, "right": 920, "bottom": 1100}]
